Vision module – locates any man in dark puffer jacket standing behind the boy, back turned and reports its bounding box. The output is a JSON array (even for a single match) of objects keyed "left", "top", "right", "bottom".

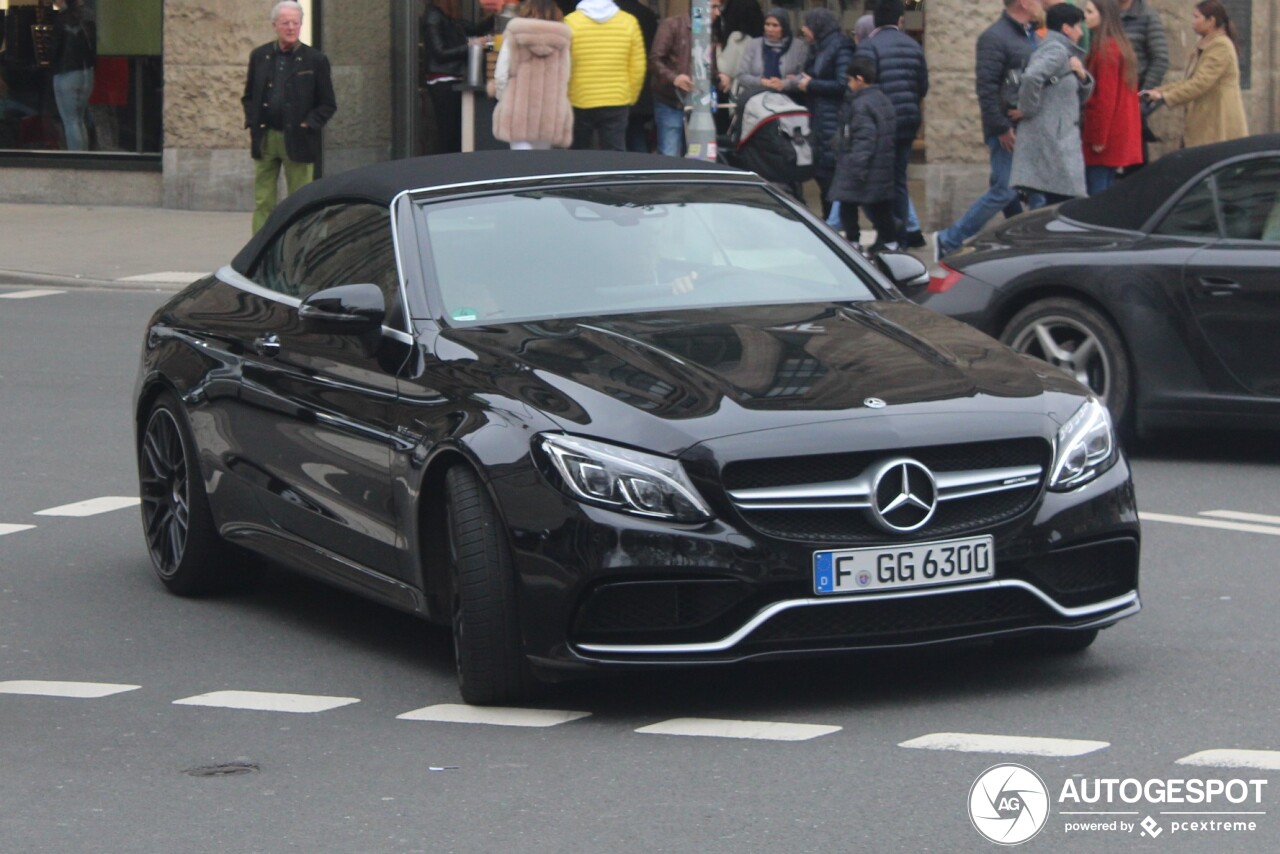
[{"left": 858, "top": 0, "right": 929, "bottom": 246}]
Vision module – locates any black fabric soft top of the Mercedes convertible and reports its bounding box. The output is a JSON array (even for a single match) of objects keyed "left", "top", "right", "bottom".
[{"left": 232, "top": 150, "right": 746, "bottom": 274}]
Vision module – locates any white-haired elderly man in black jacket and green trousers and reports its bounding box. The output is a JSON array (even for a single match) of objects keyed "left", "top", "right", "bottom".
[{"left": 241, "top": 0, "right": 338, "bottom": 232}]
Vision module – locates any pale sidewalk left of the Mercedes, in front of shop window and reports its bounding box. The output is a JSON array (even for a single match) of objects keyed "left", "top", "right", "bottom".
[{"left": 0, "top": 204, "right": 251, "bottom": 291}]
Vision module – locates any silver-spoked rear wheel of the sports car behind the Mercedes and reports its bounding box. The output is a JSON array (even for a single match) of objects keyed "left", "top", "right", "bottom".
[{"left": 1000, "top": 297, "right": 1133, "bottom": 431}]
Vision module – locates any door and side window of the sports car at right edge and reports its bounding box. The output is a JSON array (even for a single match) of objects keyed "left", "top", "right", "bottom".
[{"left": 1183, "top": 157, "right": 1280, "bottom": 397}]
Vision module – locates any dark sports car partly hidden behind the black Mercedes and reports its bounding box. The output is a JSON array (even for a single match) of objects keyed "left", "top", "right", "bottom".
[{"left": 909, "top": 134, "right": 1280, "bottom": 434}]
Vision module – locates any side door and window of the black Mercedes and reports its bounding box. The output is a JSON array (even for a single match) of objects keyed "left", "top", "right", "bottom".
[{"left": 236, "top": 202, "right": 411, "bottom": 575}]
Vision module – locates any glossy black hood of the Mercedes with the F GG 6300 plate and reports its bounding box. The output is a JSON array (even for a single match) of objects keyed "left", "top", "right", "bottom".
[{"left": 440, "top": 301, "right": 1084, "bottom": 453}]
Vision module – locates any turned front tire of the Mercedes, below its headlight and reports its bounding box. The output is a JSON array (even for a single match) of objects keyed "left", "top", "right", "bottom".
[{"left": 444, "top": 466, "right": 534, "bottom": 705}]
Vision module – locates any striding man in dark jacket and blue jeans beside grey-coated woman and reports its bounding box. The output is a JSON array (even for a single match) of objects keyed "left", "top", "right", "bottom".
[{"left": 933, "top": 0, "right": 1041, "bottom": 257}]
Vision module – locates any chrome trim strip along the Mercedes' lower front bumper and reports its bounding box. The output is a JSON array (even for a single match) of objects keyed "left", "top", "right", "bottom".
[{"left": 573, "top": 579, "right": 1140, "bottom": 656}]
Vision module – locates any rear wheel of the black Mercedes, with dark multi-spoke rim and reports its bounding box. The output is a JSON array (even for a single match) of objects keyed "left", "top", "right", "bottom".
[{"left": 138, "top": 392, "right": 246, "bottom": 595}]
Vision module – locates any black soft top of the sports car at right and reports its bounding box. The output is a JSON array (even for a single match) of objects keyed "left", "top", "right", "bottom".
[{"left": 1057, "top": 133, "right": 1280, "bottom": 232}]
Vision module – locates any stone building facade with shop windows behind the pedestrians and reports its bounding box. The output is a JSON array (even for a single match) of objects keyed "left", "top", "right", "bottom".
[{"left": 0, "top": 0, "right": 1280, "bottom": 227}]
